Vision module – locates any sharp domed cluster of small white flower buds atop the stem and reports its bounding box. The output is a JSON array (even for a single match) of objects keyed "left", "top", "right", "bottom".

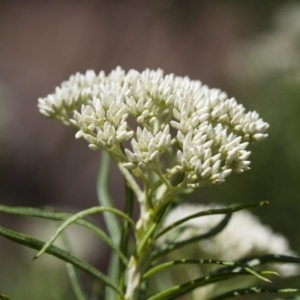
[{"left": 38, "top": 67, "right": 269, "bottom": 187}]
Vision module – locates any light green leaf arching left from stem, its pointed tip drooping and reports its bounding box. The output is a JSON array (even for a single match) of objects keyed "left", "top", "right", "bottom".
[{"left": 35, "top": 206, "right": 135, "bottom": 258}]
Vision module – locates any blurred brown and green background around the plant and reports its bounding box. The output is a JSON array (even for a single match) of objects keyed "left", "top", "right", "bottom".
[{"left": 0, "top": 0, "right": 300, "bottom": 300}]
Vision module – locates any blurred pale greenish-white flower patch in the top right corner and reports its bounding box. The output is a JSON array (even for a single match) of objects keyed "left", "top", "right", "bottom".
[{"left": 231, "top": 3, "right": 300, "bottom": 80}]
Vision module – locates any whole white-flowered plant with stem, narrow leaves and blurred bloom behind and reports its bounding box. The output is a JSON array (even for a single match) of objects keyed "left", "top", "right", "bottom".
[{"left": 0, "top": 67, "right": 299, "bottom": 300}]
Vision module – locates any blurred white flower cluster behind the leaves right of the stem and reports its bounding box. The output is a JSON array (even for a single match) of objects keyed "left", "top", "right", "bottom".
[{"left": 164, "top": 204, "right": 300, "bottom": 277}]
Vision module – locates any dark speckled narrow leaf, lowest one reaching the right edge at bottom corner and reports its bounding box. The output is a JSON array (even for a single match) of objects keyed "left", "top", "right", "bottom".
[{"left": 210, "top": 287, "right": 300, "bottom": 300}]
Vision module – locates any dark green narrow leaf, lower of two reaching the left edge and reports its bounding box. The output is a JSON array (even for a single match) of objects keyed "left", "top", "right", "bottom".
[{"left": 0, "top": 226, "right": 122, "bottom": 295}]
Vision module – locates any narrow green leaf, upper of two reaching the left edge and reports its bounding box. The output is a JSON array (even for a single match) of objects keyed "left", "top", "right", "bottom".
[{"left": 0, "top": 205, "right": 127, "bottom": 264}]
